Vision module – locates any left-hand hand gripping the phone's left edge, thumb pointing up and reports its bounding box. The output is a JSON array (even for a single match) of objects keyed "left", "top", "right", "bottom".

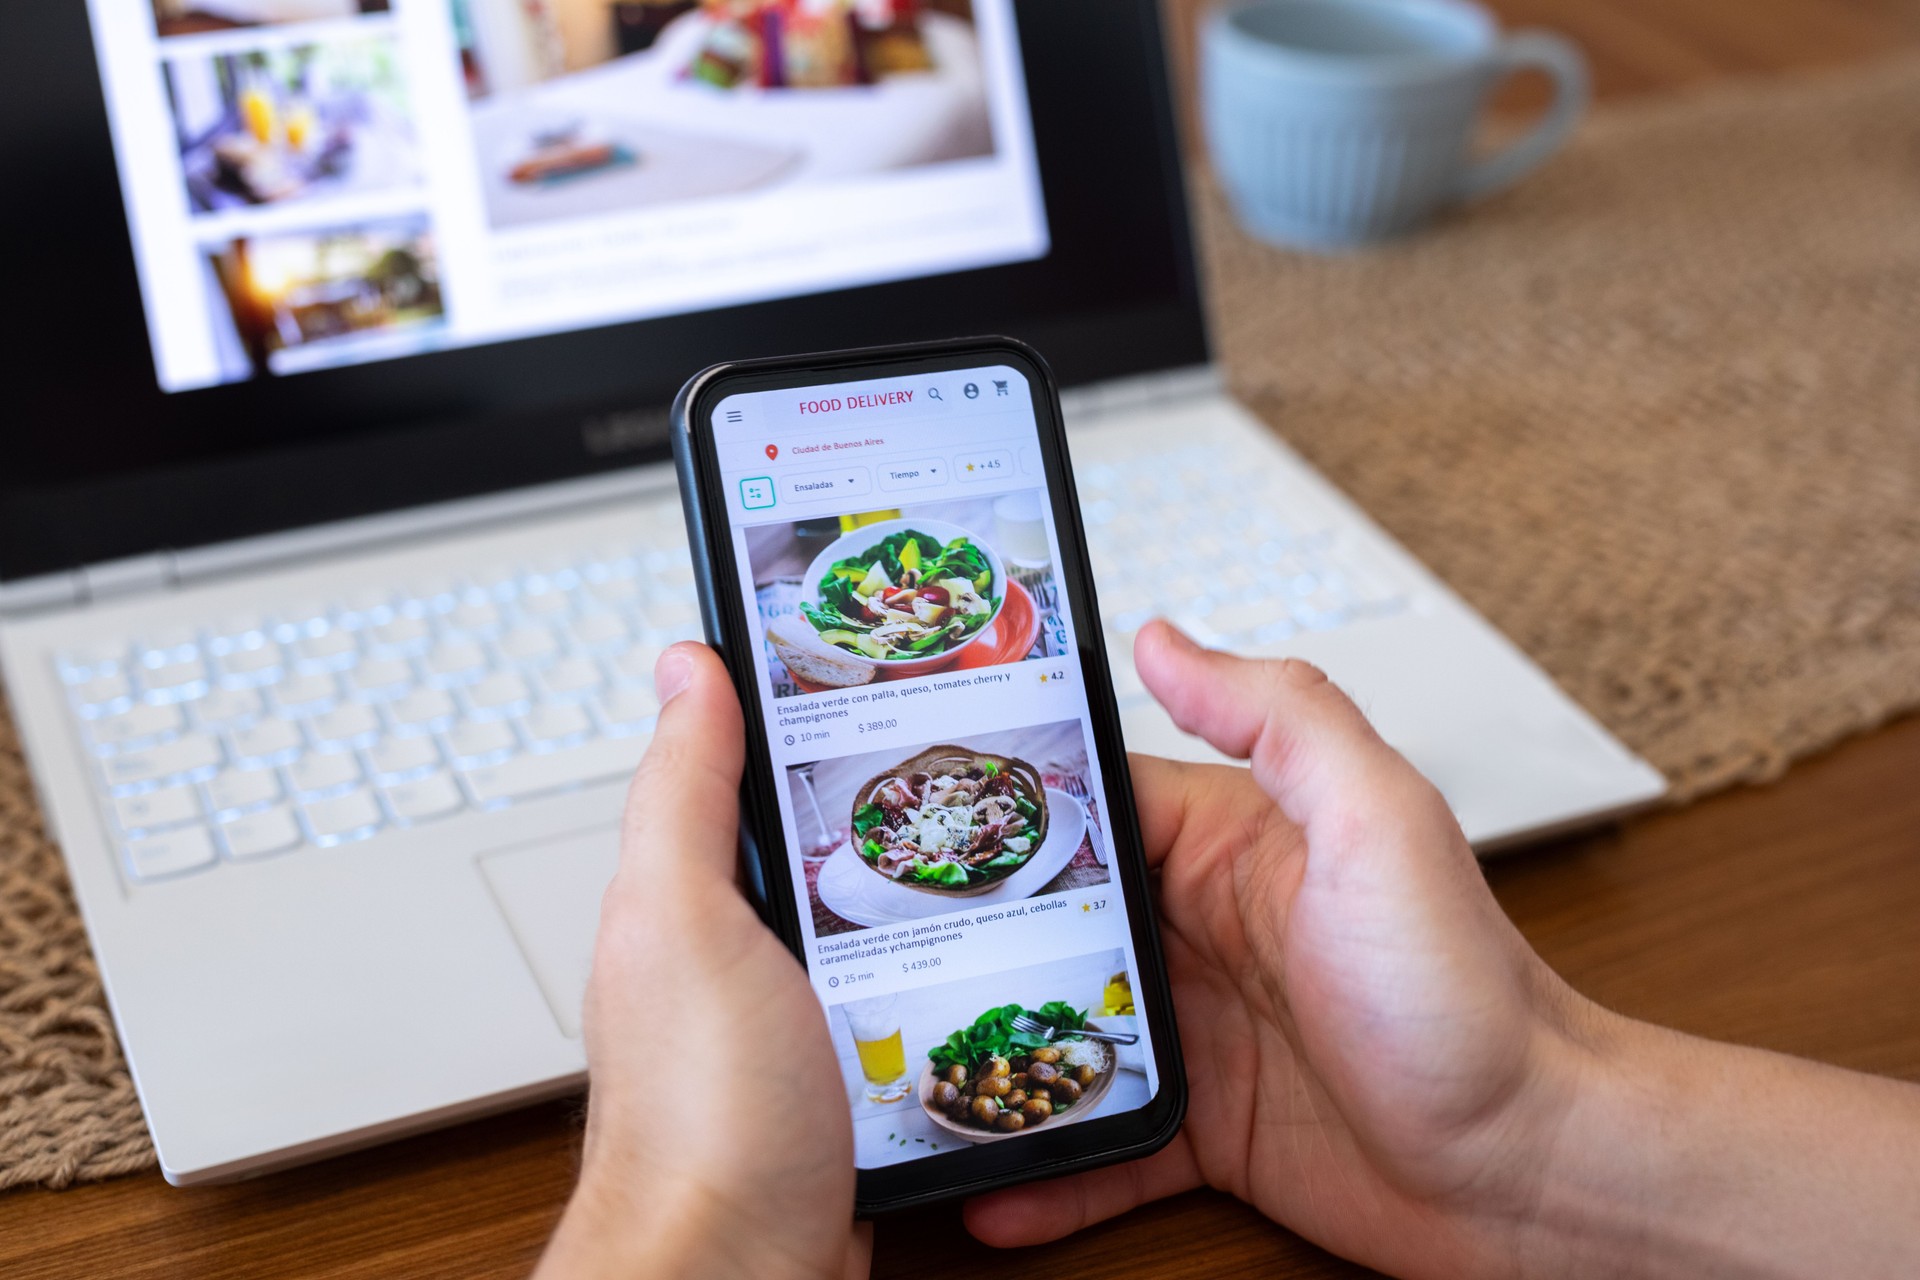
[{"left": 538, "top": 645, "right": 872, "bottom": 1280}]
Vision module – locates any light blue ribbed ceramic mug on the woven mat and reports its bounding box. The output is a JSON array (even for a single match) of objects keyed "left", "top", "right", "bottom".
[{"left": 1202, "top": 0, "right": 1588, "bottom": 249}]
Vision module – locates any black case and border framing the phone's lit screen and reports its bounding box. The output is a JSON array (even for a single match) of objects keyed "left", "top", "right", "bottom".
[{"left": 670, "top": 336, "right": 1187, "bottom": 1217}]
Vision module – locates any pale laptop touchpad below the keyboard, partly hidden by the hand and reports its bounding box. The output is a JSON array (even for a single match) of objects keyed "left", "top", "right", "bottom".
[{"left": 480, "top": 827, "right": 620, "bottom": 1040}]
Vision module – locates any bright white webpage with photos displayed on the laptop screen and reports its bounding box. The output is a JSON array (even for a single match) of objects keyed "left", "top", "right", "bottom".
[{"left": 88, "top": 0, "right": 1048, "bottom": 391}]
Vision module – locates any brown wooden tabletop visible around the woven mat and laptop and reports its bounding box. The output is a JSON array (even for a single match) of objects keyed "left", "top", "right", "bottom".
[{"left": 0, "top": 0, "right": 1920, "bottom": 1280}]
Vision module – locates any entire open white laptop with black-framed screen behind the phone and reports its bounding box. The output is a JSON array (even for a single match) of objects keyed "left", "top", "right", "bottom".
[{"left": 0, "top": 0, "right": 1663, "bottom": 1184}]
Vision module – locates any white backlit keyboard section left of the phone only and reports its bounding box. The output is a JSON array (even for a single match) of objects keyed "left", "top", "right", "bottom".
[{"left": 60, "top": 537, "right": 701, "bottom": 879}]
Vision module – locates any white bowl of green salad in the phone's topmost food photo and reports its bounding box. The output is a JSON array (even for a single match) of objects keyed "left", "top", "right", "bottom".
[{"left": 766, "top": 518, "right": 1010, "bottom": 689}]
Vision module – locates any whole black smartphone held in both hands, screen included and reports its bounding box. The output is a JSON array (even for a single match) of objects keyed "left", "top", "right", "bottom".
[{"left": 674, "top": 338, "right": 1187, "bottom": 1213}]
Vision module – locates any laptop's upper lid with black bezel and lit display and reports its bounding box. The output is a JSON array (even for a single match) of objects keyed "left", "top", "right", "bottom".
[{"left": 0, "top": 0, "right": 1208, "bottom": 583}]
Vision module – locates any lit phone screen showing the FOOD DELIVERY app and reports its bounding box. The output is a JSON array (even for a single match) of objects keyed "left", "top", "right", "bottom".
[{"left": 712, "top": 367, "right": 1158, "bottom": 1169}]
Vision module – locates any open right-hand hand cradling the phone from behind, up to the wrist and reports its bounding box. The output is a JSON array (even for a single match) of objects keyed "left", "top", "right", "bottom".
[{"left": 968, "top": 624, "right": 1611, "bottom": 1276}]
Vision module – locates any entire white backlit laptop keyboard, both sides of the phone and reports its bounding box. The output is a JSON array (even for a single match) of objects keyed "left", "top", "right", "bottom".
[{"left": 60, "top": 436, "right": 1405, "bottom": 881}]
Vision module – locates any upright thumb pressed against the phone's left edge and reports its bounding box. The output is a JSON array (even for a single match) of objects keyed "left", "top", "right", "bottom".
[{"left": 620, "top": 643, "right": 747, "bottom": 883}]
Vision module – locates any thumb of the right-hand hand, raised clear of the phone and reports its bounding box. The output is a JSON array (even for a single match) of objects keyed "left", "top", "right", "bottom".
[{"left": 1135, "top": 622, "right": 1438, "bottom": 837}]
